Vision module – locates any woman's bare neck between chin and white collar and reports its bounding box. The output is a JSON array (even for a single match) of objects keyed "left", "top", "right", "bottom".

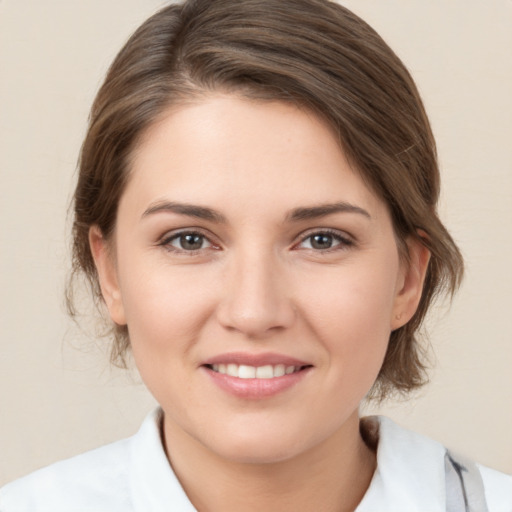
[{"left": 164, "top": 411, "right": 376, "bottom": 512}]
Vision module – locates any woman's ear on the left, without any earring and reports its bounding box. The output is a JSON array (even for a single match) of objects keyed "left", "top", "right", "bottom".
[{"left": 89, "top": 226, "right": 126, "bottom": 325}]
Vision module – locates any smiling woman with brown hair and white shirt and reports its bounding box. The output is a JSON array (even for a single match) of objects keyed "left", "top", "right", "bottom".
[{"left": 0, "top": 0, "right": 511, "bottom": 512}]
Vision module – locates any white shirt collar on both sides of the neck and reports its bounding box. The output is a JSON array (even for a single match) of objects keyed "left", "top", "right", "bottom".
[{"left": 130, "top": 409, "right": 446, "bottom": 512}]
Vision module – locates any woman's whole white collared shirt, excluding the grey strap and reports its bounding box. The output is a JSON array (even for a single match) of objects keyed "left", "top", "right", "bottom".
[{"left": 0, "top": 409, "right": 512, "bottom": 512}]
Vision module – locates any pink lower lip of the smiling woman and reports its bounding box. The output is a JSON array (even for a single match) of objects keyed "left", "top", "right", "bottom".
[{"left": 202, "top": 366, "right": 312, "bottom": 400}]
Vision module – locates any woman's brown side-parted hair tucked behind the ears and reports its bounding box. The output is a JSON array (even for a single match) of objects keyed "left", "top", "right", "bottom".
[{"left": 69, "top": 0, "right": 463, "bottom": 398}]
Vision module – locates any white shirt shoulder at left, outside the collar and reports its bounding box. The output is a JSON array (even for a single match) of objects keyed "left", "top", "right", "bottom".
[{"left": 0, "top": 439, "right": 134, "bottom": 512}]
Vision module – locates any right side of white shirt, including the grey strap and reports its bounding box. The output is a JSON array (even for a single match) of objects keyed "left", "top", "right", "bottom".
[{"left": 358, "top": 417, "right": 512, "bottom": 512}]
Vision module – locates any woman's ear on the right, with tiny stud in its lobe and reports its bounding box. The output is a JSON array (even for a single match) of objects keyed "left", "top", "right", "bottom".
[{"left": 391, "top": 233, "right": 430, "bottom": 331}]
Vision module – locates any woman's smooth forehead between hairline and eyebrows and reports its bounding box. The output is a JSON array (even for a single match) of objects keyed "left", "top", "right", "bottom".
[{"left": 123, "top": 95, "right": 383, "bottom": 223}]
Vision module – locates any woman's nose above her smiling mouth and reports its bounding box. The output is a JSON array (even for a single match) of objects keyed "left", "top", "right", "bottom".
[{"left": 217, "top": 249, "right": 296, "bottom": 339}]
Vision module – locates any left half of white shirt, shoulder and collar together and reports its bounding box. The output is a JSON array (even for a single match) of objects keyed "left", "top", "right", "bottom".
[{"left": 0, "top": 408, "right": 195, "bottom": 512}]
